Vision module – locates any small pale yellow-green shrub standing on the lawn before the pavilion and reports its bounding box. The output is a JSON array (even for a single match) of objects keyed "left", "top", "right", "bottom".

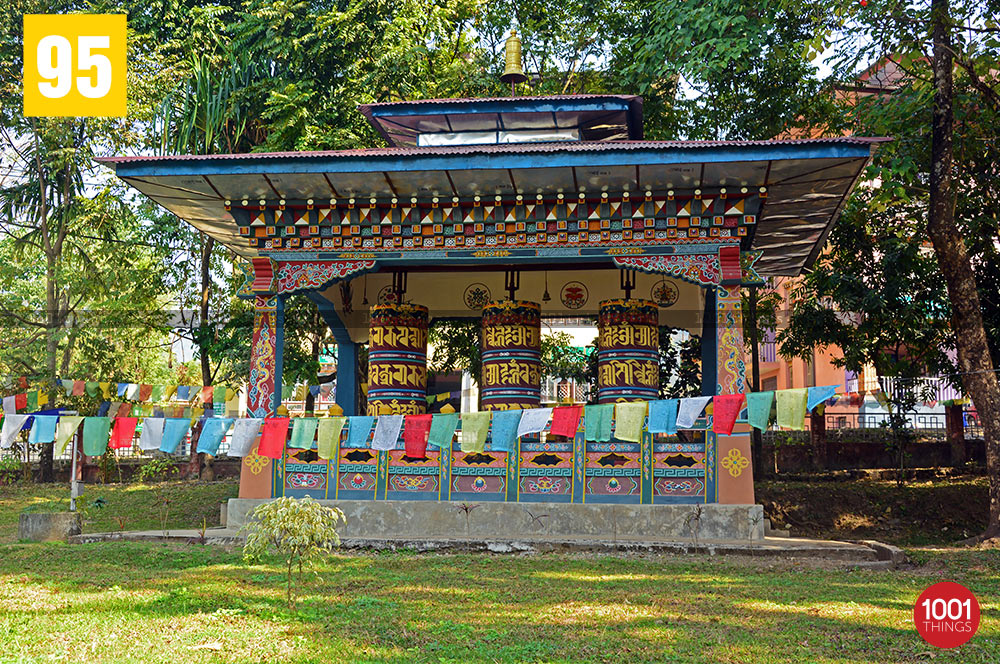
[{"left": 241, "top": 498, "right": 345, "bottom": 609}]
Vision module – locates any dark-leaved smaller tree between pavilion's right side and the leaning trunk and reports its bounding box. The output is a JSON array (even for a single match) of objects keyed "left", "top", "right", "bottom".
[{"left": 778, "top": 186, "right": 953, "bottom": 480}]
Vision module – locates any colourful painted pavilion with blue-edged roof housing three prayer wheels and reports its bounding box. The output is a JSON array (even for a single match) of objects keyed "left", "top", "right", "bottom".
[{"left": 99, "top": 95, "right": 884, "bottom": 505}]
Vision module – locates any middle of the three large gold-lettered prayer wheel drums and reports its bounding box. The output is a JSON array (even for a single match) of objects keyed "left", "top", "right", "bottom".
[{"left": 480, "top": 300, "right": 542, "bottom": 410}]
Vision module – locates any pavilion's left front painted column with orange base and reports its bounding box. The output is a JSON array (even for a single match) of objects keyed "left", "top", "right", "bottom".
[{"left": 240, "top": 295, "right": 284, "bottom": 498}]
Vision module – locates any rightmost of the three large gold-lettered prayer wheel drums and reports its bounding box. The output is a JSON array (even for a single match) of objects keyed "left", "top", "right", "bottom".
[{"left": 597, "top": 299, "right": 660, "bottom": 403}]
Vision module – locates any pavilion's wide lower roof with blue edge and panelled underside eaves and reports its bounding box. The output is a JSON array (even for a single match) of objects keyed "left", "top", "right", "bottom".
[{"left": 100, "top": 136, "right": 889, "bottom": 276}]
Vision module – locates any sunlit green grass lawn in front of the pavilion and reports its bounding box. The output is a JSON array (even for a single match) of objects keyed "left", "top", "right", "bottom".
[{"left": 0, "top": 483, "right": 1000, "bottom": 664}]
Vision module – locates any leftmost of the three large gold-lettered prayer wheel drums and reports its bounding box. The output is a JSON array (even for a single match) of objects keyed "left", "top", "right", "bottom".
[{"left": 368, "top": 304, "right": 428, "bottom": 415}]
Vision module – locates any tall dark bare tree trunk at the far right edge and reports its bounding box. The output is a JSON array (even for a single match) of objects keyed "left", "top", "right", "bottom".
[{"left": 927, "top": 0, "right": 1000, "bottom": 538}]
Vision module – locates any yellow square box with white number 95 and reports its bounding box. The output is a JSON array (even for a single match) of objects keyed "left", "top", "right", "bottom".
[{"left": 24, "top": 14, "right": 126, "bottom": 117}]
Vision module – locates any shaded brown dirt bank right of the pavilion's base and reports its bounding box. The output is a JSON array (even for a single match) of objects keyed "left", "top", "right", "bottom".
[{"left": 756, "top": 477, "right": 989, "bottom": 546}]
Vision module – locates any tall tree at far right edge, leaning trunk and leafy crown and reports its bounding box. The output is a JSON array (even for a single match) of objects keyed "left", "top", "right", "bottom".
[{"left": 788, "top": 0, "right": 1000, "bottom": 538}]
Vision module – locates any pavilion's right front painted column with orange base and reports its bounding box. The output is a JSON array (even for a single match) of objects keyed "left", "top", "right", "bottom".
[{"left": 706, "top": 284, "right": 754, "bottom": 505}]
